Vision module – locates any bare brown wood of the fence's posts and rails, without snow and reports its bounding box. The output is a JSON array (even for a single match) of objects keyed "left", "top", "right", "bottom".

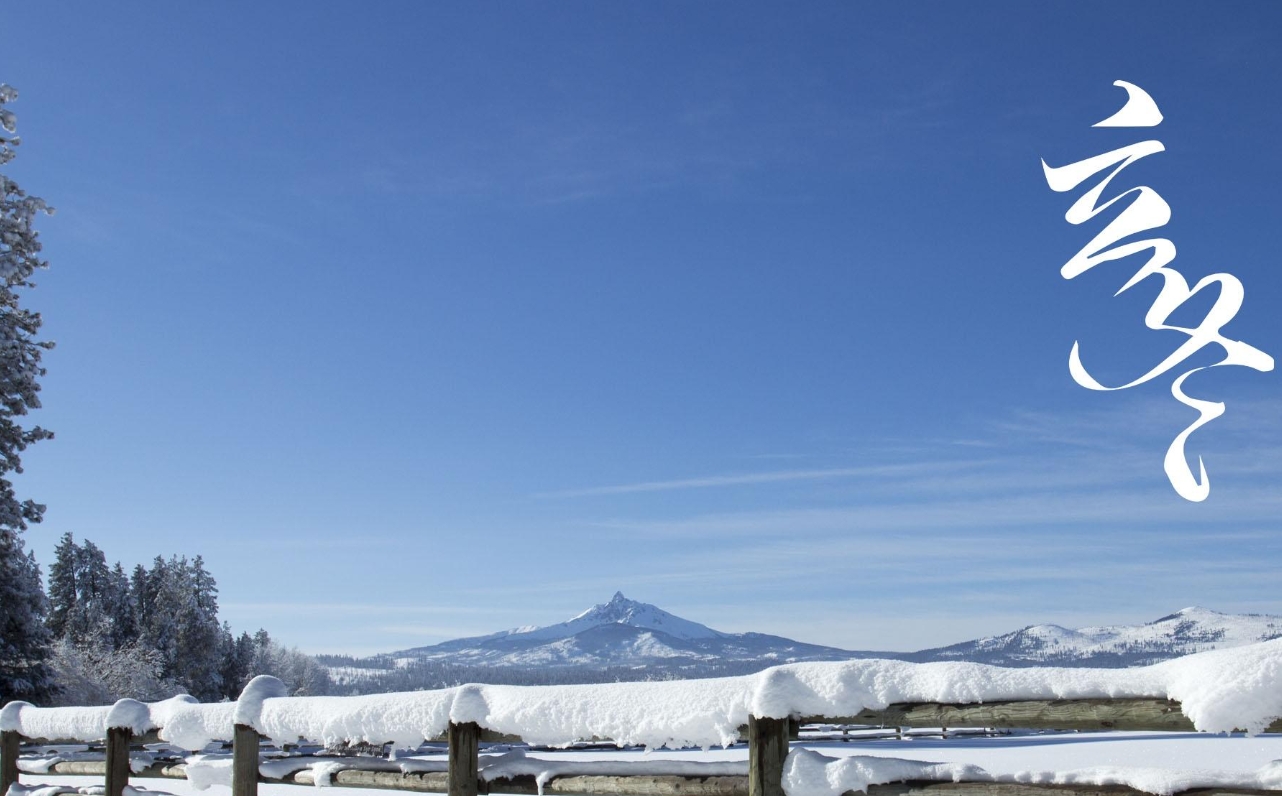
[{"left": 0, "top": 699, "right": 1282, "bottom": 796}]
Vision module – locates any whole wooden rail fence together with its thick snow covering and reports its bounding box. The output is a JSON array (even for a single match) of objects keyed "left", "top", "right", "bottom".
[{"left": 0, "top": 640, "right": 1282, "bottom": 796}]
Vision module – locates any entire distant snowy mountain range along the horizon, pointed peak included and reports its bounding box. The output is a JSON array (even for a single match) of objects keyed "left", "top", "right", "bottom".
[{"left": 318, "top": 592, "right": 1282, "bottom": 692}]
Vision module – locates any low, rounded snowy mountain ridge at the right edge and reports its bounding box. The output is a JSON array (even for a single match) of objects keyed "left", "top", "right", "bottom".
[{"left": 905, "top": 608, "right": 1282, "bottom": 668}]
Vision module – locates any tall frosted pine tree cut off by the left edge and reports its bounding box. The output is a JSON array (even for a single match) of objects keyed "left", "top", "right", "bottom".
[{"left": 0, "top": 83, "right": 53, "bottom": 702}]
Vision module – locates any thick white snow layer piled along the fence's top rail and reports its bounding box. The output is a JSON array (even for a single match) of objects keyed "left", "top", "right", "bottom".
[{"left": 0, "top": 638, "right": 1282, "bottom": 750}]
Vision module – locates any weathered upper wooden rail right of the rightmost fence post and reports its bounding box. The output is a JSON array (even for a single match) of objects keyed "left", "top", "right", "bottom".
[{"left": 801, "top": 699, "right": 1282, "bottom": 732}]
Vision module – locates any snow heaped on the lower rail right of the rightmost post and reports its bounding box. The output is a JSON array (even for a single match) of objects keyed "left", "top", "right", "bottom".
[{"left": 783, "top": 749, "right": 1282, "bottom": 796}]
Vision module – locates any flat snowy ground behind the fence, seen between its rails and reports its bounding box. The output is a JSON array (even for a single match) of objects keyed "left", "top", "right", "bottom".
[{"left": 23, "top": 732, "right": 1282, "bottom": 796}]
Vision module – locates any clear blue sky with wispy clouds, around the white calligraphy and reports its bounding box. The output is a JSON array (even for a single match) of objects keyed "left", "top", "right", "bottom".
[{"left": 0, "top": 1, "right": 1282, "bottom": 652}]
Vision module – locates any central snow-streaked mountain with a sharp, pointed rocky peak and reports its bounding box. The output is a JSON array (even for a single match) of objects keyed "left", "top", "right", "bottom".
[{"left": 392, "top": 592, "right": 853, "bottom": 669}]
